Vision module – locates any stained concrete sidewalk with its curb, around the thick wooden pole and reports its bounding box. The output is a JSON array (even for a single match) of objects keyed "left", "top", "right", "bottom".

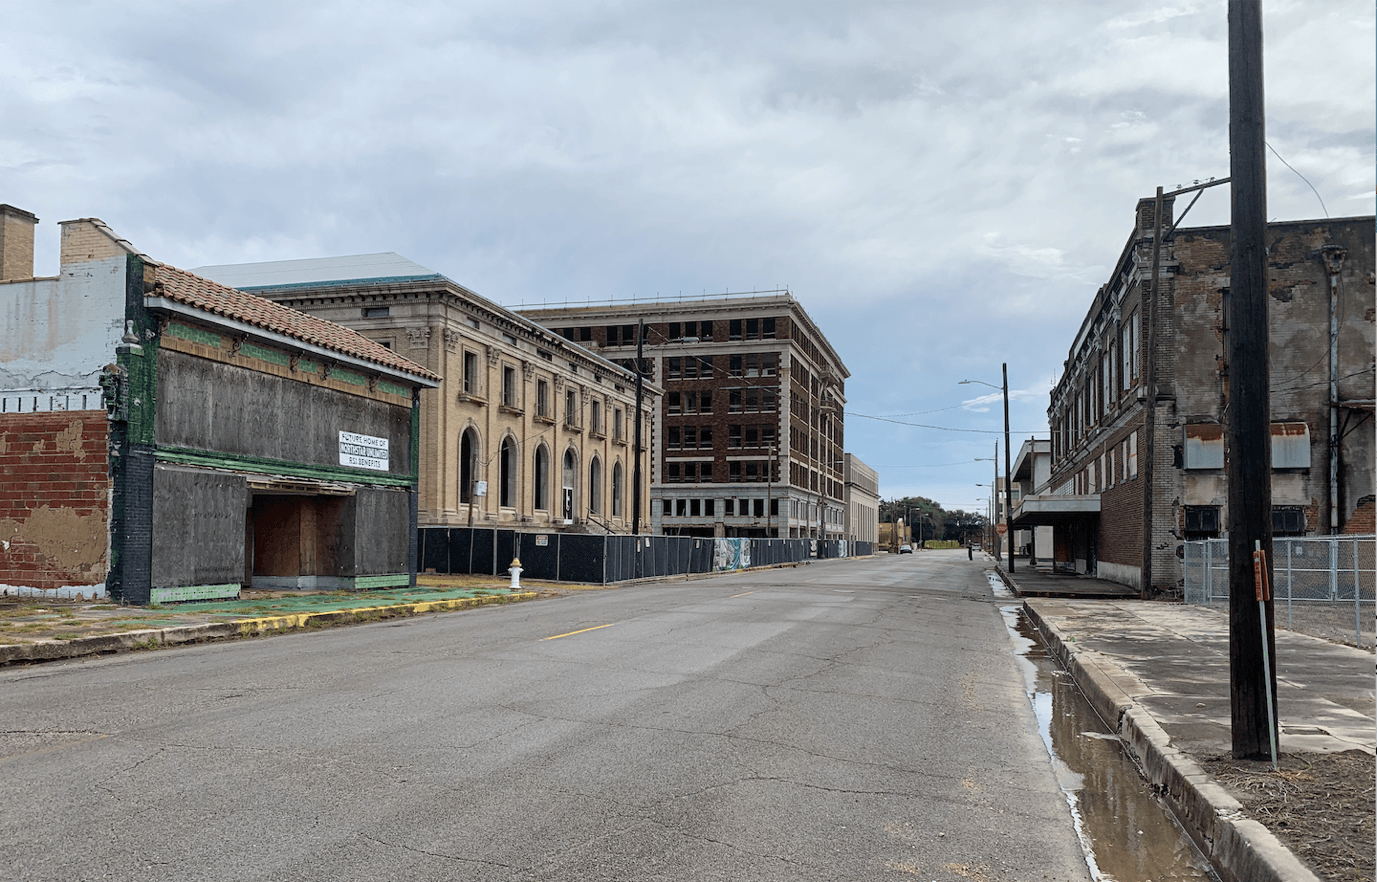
[{"left": 1018, "top": 571, "right": 1377, "bottom": 882}]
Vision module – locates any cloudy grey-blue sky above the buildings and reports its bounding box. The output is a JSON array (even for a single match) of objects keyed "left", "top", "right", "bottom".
[{"left": 0, "top": 0, "right": 1377, "bottom": 510}]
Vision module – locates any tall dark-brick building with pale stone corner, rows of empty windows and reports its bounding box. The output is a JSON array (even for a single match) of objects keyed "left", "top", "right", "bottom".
[{"left": 522, "top": 292, "right": 851, "bottom": 539}]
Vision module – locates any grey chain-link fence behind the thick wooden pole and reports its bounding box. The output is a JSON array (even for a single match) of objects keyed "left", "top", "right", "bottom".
[{"left": 1183, "top": 535, "right": 1377, "bottom": 649}]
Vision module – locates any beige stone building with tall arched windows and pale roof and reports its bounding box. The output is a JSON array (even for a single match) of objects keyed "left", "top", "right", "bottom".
[{"left": 197, "top": 253, "right": 661, "bottom": 533}]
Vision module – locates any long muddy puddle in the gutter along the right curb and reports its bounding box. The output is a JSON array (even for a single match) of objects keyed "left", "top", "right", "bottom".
[{"left": 1000, "top": 599, "right": 1219, "bottom": 882}]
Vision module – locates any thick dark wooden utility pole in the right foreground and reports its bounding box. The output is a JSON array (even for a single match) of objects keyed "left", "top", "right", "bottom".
[{"left": 1228, "top": 0, "right": 1276, "bottom": 760}]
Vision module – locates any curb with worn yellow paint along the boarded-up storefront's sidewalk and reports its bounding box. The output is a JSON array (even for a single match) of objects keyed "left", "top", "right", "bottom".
[{"left": 0, "top": 592, "right": 537, "bottom": 666}]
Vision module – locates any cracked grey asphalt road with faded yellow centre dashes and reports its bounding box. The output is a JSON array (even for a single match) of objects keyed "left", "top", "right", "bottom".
[{"left": 0, "top": 550, "right": 1089, "bottom": 882}]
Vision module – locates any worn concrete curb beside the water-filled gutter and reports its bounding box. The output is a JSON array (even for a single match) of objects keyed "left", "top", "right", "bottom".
[{"left": 1023, "top": 601, "right": 1319, "bottom": 882}]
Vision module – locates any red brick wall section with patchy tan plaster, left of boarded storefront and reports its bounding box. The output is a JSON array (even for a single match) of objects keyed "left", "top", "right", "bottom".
[{"left": 0, "top": 410, "right": 110, "bottom": 593}]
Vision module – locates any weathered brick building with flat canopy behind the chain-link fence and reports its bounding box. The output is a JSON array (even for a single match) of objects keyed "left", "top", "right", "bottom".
[{"left": 1016, "top": 194, "right": 1374, "bottom": 596}]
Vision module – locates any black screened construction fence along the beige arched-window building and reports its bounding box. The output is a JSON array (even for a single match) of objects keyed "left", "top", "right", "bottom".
[{"left": 417, "top": 527, "right": 874, "bottom": 585}]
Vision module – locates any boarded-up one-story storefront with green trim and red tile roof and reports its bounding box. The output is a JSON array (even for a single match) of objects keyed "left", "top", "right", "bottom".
[{"left": 0, "top": 206, "right": 439, "bottom": 603}]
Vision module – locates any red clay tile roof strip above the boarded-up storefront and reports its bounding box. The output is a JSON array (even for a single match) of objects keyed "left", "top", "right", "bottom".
[{"left": 146, "top": 264, "right": 439, "bottom": 381}]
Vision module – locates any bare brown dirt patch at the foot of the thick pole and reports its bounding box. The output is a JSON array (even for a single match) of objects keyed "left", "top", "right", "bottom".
[{"left": 1202, "top": 750, "right": 1377, "bottom": 882}]
